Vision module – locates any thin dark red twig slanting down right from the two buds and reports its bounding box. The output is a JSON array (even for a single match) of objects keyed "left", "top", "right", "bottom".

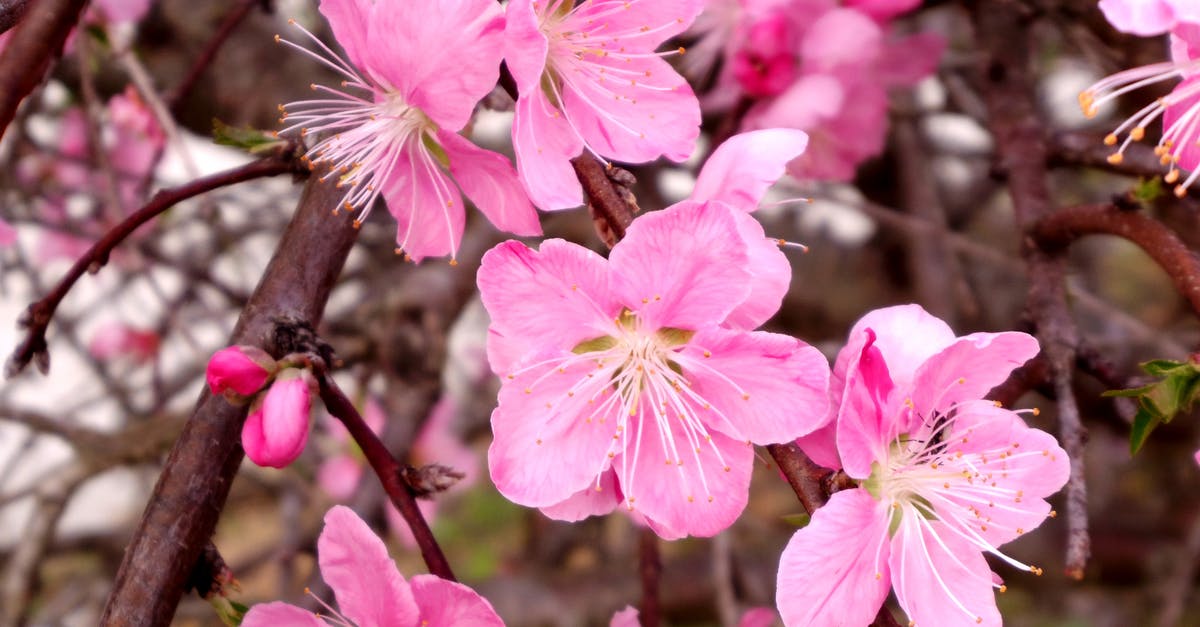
[{"left": 318, "top": 374, "right": 456, "bottom": 581}]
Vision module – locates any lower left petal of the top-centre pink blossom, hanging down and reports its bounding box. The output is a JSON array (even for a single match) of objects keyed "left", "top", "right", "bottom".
[{"left": 509, "top": 88, "right": 583, "bottom": 211}]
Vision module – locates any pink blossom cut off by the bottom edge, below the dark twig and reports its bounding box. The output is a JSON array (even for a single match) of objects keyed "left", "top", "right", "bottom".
[{"left": 241, "top": 506, "right": 504, "bottom": 627}]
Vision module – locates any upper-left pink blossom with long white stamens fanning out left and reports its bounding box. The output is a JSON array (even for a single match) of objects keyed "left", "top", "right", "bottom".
[{"left": 278, "top": 0, "right": 541, "bottom": 261}]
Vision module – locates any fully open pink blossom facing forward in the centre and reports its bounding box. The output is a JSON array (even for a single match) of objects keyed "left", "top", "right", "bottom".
[{"left": 479, "top": 201, "right": 828, "bottom": 538}]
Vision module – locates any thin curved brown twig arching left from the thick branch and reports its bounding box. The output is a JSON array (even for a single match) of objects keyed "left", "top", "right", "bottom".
[{"left": 5, "top": 150, "right": 304, "bottom": 377}]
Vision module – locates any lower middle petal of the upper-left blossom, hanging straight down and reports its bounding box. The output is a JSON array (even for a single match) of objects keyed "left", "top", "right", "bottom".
[{"left": 383, "top": 141, "right": 467, "bottom": 262}]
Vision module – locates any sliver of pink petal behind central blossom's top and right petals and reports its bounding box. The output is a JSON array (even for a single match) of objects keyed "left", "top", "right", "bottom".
[{"left": 724, "top": 213, "right": 792, "bottom": 329}]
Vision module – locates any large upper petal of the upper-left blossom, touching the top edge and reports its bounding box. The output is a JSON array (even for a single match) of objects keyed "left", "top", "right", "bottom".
[{"left": 362, "top": 0, "right": 504, "bottom": 131}]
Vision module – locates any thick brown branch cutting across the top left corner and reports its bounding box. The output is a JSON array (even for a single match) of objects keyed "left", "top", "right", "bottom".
[{"left": 0, "top": 0, "right": 88, "bottom": 135}]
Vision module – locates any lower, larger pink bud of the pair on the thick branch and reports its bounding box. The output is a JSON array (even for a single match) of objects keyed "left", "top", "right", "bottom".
[{"left": 241, "top": 368, "right": 316, "bottom": 468}]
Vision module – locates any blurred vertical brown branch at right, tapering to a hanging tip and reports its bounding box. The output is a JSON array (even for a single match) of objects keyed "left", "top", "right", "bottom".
[{"left": 972, "top": 0, "right": 1091, "bottom": 577}]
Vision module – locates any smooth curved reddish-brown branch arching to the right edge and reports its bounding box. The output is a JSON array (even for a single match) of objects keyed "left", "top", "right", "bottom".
[{"left": 1033, "top": 204, "right": 1200, "bottom": 316}]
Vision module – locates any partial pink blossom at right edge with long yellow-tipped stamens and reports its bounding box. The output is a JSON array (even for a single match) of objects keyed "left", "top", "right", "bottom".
[{"left": 1079, "top": 18, "right": 1200, "bottom": 192}]
